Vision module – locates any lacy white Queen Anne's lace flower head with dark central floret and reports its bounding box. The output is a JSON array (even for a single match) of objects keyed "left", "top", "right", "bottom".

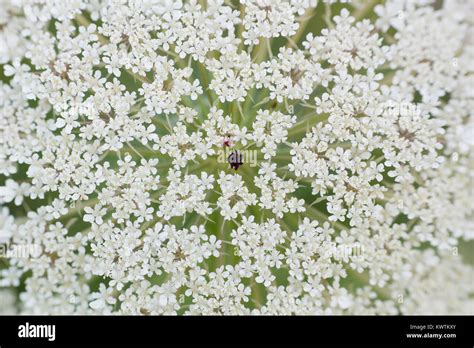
[{"left": 0, "top": 0, "right": 474, "bottom": 315}]
